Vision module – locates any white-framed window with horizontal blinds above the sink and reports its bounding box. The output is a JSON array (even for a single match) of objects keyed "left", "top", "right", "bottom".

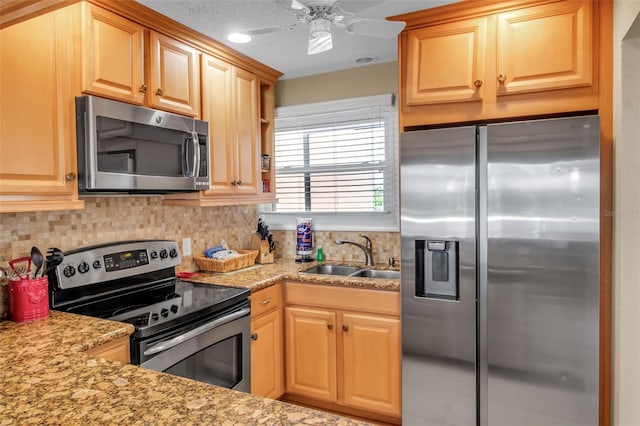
[{"left": 261, "top": 95, "right": 398, "bottom": 231}]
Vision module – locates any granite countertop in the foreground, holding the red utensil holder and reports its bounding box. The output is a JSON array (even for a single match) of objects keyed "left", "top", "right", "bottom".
[{"left": 0, "top": 311, "right": 365, "bottom": 426}]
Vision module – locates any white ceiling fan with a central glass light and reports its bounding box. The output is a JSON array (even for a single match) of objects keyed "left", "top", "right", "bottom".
[{"left": 228, "top": 0, "right": 405, "bottom": 55}]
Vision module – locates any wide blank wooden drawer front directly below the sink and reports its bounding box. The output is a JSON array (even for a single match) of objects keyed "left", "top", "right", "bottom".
[{"left": 285, "top": 282, "right": 400, "bottom": 315}]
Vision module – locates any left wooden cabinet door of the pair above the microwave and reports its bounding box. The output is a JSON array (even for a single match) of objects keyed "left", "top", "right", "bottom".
[{"left": 82, "top": 3, "right": 146, "bottom": 105}]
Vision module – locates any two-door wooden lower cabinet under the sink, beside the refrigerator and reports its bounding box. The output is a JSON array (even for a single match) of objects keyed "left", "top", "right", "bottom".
[{"left": 285, "top": 283, "right": 401, "bottom": 423}]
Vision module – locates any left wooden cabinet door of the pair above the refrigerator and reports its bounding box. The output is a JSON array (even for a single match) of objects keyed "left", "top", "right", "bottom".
[{"left": 405, "top": 18, "right": 487, "bottom": 105}]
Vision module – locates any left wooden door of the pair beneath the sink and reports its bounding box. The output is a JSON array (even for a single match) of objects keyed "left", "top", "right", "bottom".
[{"left": 285, "top": 307, "right": 337, "bottom": 402}]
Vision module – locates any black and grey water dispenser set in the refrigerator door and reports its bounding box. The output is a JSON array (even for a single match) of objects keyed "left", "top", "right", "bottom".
[{"left": 415, "top": 240, "right": 460, "bottom": 300}]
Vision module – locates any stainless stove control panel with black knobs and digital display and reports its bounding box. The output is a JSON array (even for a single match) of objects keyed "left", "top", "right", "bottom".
[{"left": 55, "top": 240, "right": 180, "bottom": 289}]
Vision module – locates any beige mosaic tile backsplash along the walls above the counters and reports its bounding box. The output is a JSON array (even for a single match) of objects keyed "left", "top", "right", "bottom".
[{"left": 0, "top": 196, "right": 400, "bottom": 270}]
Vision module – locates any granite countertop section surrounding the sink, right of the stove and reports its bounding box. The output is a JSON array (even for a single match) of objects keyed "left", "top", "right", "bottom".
[{"left": 182, "top": 259, "right": 400, "bottom": 291}]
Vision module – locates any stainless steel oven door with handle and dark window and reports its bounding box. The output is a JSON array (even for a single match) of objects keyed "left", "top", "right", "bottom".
[{"left": 139, "top": 305, "right": 251, "bottom": 392}]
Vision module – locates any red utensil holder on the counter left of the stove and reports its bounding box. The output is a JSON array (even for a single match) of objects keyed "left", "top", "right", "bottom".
[{"left": 9, "top": 276, "right": 49, "bottom": 322}]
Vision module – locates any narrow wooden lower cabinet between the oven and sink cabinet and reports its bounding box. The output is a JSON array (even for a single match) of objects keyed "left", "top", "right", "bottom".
[{"left": 251, "top": 284, "right": 284, "bottom": 399}]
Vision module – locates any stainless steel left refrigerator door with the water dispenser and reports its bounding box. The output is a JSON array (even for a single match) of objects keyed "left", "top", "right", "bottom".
[{"left": 400, "top": 126, "right": 476, "bottom": 426}]
